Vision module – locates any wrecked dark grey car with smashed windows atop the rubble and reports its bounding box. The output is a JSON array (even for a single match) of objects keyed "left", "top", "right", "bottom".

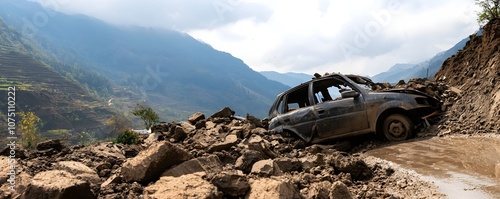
[{"left": 268, "top": 73, "right": 441, "bottom": 143}]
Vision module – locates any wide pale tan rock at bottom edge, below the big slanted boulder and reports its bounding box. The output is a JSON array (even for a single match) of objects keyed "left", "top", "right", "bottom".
[{"left": 144, "top": 172, "right": 221, "bottom": 199}]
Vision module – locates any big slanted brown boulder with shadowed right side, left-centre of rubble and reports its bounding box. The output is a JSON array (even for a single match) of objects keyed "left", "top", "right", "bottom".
[{"left": 121, "top": 141, "right": 191, "bottom": 183}]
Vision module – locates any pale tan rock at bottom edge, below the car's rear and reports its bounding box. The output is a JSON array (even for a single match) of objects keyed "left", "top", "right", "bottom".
[{"left": 245, "top": 178, "right": 302, "bottom": 199}]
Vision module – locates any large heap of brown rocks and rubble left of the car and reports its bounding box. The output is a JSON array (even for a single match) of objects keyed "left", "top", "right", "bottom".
[{"left": 0, "top": 108, "right": 440, "bottom": 199}]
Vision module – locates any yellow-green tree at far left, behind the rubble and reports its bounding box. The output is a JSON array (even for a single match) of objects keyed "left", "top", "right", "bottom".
[{"left": 18, "top": 111, "right": 42, "bottom": 149}]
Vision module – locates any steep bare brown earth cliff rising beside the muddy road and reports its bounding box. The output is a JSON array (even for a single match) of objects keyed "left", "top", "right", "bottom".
[{"left": 435, "top": 20, "right": 500, "bottom": 133}]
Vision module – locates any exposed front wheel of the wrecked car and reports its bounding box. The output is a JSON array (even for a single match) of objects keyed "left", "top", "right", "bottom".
[{"left": 382, "top": 114, "right": 415, "bottom": 141}]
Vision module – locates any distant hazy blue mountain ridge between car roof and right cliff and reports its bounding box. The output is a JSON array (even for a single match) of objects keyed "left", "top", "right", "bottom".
[{"left": 371, "top": 38, "right": 469, "bottom": 83}]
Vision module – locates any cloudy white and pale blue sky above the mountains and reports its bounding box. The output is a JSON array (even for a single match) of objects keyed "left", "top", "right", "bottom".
[{"left": 36, "top": 0, "right": 479, "bottom": 76}]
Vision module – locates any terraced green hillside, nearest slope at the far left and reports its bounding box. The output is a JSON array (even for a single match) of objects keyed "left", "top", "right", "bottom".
[{"left": 0, "top": 18, "right": 116, "bottom": 139}]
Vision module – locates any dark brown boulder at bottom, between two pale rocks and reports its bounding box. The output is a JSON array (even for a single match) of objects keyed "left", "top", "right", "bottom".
[{"left": 211, "top": 170, "right": 250, "bottom": 198}]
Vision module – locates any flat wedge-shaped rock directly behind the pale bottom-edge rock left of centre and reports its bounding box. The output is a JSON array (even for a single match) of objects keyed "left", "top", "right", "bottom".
[{"left": 161, "top": 155, "right": 222, "bottom": 177}]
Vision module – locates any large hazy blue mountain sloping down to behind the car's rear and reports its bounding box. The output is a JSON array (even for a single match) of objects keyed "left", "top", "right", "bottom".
[{"left": 0, "top": 0, "right": 288, "bottom": 121}]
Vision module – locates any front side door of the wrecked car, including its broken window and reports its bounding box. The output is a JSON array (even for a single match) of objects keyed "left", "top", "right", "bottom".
[{"left": 313, "top": 78, "right": 369, "bottom": 138}]
